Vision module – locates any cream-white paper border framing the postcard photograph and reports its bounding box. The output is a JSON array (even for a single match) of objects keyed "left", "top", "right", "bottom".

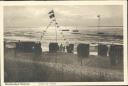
[{"left": 0, "top": 1, "right": 128, "bottom": 86}]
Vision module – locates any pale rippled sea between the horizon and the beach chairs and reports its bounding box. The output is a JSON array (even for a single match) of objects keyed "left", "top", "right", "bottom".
[{"left": 4, "top": 27, "right": 123, "bottom": 54}]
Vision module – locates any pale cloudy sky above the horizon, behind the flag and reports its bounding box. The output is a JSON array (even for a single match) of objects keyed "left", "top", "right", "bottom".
[{"left": 4, "top": 5, "right": 123, "bottom": 27}]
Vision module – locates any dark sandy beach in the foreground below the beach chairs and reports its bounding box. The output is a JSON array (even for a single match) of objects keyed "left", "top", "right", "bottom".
[{"left": 4, "top": 48, "right": 123, "bottom": 82}]
